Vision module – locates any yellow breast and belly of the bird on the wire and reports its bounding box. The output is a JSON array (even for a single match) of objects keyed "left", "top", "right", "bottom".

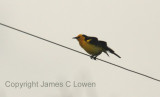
[{"left": 79, "top": 41, "right": 102, "bottom": 55}]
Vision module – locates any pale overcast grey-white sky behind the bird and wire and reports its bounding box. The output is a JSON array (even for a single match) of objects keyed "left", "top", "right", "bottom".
[{"left": 0, "top": 0, "right": 160, "bottom": 97}]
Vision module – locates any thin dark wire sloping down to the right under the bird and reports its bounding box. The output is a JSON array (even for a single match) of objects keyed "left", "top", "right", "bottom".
[{"left": 0, "top": 23, "right": 160, "bottom": 82}]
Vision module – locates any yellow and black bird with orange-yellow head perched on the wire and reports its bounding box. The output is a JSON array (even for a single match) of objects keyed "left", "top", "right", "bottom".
[{"left": 73, "top": 34, "right": 121, "bottom": 60}]
